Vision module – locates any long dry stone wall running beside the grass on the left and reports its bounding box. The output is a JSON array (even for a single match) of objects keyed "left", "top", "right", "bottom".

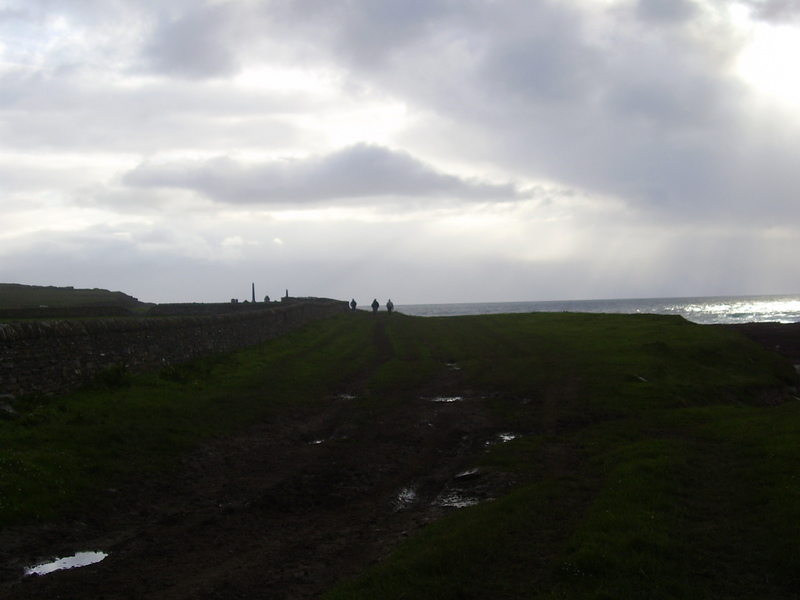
[{"left": 0, "top": 300, "right": 348, "bottom": 396}]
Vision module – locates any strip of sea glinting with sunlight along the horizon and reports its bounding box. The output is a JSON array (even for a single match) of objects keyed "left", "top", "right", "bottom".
[{"left": 396, "top": 295, "right": 800, "bottom": 325}]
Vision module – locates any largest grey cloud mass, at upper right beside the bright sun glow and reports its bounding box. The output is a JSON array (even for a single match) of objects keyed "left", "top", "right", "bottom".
[{"left": 262, "top": 0, "right": 800, "bottom": 219}]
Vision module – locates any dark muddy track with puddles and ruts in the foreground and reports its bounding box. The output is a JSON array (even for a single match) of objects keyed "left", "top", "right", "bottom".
[{"left": 0, "top": 382, "right": 544, "bottom": 600}]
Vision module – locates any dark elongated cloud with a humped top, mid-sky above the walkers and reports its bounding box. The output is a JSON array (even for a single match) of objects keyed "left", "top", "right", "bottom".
[{"left": 123, "top": 144, "right": 522, "bottom": 204}]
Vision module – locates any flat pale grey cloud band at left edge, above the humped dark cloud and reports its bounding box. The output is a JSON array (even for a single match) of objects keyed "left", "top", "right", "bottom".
[{"left": 0, "top": 74, "right": 312, "bottom": 153}]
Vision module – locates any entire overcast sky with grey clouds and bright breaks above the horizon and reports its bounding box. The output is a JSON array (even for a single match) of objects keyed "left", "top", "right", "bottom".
[{"left": 0, "top": 0, "right": 800, "bottom": 305}]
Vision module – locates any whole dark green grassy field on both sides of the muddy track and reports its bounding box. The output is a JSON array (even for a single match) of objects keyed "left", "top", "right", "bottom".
[{"left": 0, "top": 313, "right": 800, "bottom": 600}]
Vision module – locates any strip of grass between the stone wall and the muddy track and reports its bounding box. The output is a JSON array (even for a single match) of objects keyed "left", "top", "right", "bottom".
[{"left": 0, "top": 319, "right": 374, "bottom": 526}]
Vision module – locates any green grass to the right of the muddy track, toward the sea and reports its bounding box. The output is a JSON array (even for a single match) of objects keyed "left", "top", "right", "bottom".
[{"left": 327, "top": 314, "right": 800, "bottom": 599}]
